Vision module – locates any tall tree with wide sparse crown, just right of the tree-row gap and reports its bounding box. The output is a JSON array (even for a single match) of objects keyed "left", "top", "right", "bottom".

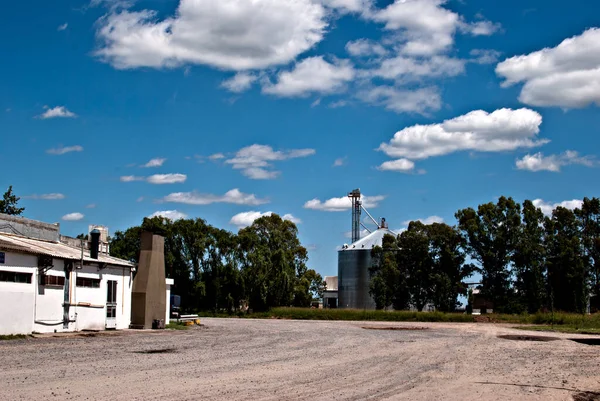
[{"left": 456, "top": 196, "right": 521, "bottom": 312}]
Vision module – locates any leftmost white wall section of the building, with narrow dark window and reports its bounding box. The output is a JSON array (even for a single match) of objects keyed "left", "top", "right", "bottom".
[{"left": 0, "top": 252, "right": 37, "bottom": 334}]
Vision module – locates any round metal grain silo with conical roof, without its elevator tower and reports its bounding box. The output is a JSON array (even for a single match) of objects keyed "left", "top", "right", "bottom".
[{"left": 338, "top": 227, "right": 396, "bottom": 309}]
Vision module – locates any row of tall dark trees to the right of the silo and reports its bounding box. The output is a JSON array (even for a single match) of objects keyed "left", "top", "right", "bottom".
[{"left": 370, "top": 197, "right": 600, "bottom": 313}]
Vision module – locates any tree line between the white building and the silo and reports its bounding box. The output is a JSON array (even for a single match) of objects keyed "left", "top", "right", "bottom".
[{"left": 110, "top": 214, "right": 325, "bottom": 313}]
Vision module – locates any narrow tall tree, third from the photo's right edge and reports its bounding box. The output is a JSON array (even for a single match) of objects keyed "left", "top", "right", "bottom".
[{"left": 513, "top": 200, "right": 547, "bottom": 313}]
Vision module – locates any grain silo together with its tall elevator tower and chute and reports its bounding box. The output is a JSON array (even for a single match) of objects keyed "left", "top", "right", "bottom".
[{"left": 336, "top": 189, "right": 396, "bottom": 309}]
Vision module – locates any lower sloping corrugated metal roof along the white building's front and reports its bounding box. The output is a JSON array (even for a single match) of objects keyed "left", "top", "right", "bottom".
[{"left": 0, "top": 233, "right": 135, "bottom": 267}]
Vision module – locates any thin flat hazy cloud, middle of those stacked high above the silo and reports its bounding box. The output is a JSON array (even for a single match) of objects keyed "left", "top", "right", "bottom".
[{"left": 373, "top": 56, "right": 465, "bottom": 81}]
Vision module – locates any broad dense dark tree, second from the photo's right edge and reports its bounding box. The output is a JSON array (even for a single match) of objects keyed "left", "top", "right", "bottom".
[{"left": 544, "top": 207, "right": 589, "bottom": 313}]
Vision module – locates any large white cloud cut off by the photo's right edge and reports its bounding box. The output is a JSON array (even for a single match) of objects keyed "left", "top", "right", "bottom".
[{"left": 496, "top": 28, "right": 600, "bottom": 108}]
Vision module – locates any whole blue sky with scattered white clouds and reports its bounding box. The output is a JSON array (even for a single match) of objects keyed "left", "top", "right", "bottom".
[{"left": 0, "top": 0, "right": 600, "bottom": 275}]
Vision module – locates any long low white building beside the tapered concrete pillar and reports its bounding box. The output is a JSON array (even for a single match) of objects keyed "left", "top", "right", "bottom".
[{"left": 0, "top": 215, "right": 173, "bottom": 334}]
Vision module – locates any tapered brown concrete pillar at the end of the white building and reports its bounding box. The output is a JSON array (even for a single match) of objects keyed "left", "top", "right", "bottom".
[{"left": 131, "top": 231, "right": 167, "bottom": 329}]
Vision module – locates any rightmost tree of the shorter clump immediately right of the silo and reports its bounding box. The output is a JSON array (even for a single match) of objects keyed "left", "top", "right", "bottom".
[{"left": 427, "top": 223, "right": 475, "bottom": 312}]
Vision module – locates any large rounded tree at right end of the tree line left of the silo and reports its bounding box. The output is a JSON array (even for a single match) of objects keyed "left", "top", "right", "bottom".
[{"left": 238, "top": 214, "right": 308, "bottom": 310}]
